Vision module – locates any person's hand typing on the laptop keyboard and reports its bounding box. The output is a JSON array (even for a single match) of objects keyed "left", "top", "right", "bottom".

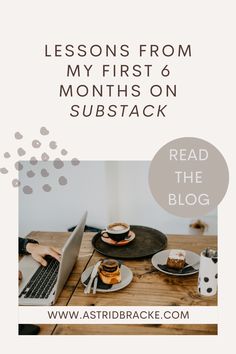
[{"left": 26, "top": 242, "right": 61, "bottom": 267}]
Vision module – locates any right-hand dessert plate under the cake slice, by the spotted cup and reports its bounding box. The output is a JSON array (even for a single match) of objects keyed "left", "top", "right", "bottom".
[{"left": 152, "top": 250, "right": 200, "bottom": 277}]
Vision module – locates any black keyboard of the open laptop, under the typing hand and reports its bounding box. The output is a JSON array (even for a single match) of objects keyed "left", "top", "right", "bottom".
[{"left": 19, "top": 256, "right": 60, "bottom": 299}]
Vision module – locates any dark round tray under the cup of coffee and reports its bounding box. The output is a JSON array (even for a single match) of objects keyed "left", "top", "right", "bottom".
[{"left": 92, "top": 225, "right": 167, "bottom": 259}]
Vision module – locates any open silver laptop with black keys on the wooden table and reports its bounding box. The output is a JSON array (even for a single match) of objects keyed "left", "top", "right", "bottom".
[{"left": 19, "top": 212, "right": 87, "bottom": 306}]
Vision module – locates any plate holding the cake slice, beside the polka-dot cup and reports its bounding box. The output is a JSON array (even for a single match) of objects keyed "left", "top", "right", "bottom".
[{"left": 152, "top": 250, "right": 200, "bottom": 277}]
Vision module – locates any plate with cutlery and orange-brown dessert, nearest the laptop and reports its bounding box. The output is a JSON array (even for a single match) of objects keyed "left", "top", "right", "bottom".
[{"left": 81, "top": 264, "right": 133, "bottom": 293}]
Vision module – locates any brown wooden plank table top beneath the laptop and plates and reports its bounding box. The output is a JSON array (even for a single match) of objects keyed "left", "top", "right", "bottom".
[{"left": 24, "top": 232, "right": 217, "bottom": 335}]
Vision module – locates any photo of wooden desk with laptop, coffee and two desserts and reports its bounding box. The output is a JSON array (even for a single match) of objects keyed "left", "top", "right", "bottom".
[{"left": 18, "top": 161, "right": 218, "bottom": 335}]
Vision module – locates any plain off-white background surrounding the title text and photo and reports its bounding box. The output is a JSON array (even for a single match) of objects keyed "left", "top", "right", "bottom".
[{"left": 0, "top": 0, "right": 236, "bottom": 353}]
